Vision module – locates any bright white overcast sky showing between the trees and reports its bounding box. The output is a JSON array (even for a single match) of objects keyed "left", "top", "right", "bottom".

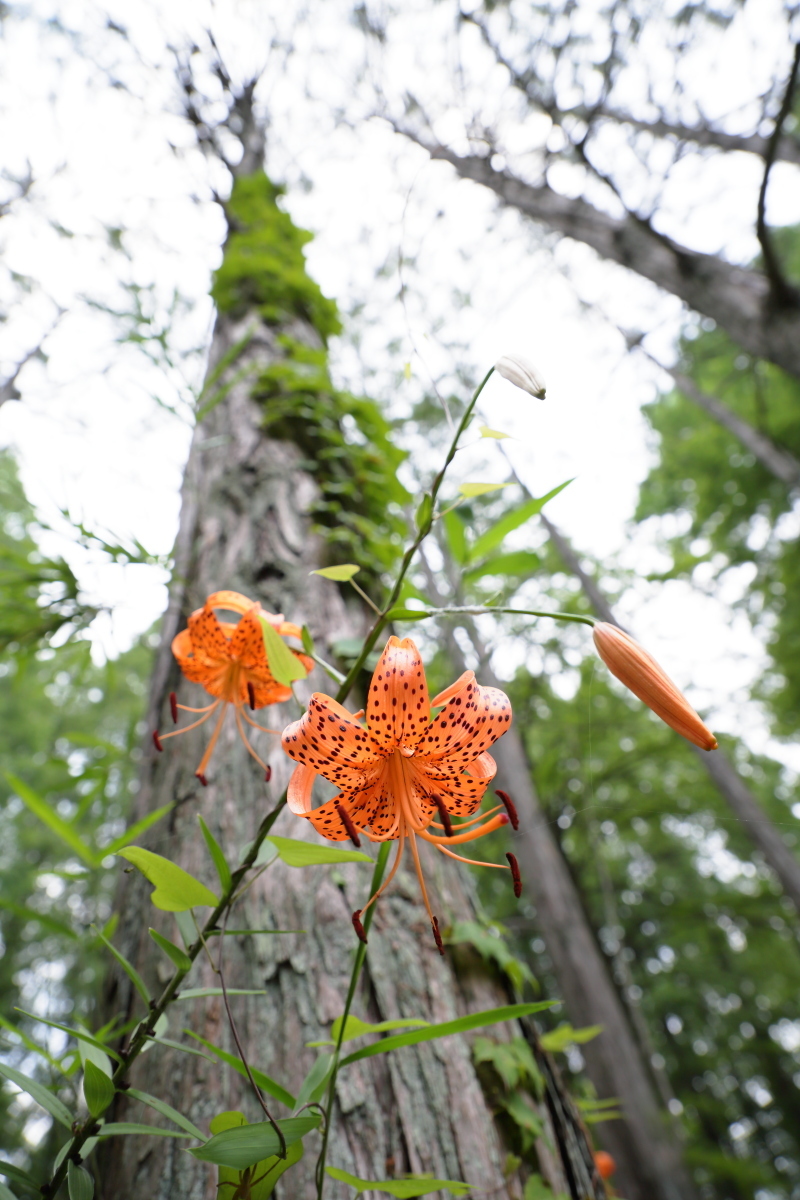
[{"left": 0, "top": 0, "right": 800, "bottom": 767}]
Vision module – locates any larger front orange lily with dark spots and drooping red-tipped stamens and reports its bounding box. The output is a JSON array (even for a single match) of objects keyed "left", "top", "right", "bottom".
[{"left": 282, "top": 637, "right": 521, "bottom": 954}]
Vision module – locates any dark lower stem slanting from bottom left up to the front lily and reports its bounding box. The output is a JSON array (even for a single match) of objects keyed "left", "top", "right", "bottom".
[{"left": 40, "top": 792, "right": 287, "bottom": 1196}]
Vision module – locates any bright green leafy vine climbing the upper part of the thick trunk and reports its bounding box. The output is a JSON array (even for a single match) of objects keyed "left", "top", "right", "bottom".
[{"left": 211, "top": 172, "right": 409, "bottom": 588}]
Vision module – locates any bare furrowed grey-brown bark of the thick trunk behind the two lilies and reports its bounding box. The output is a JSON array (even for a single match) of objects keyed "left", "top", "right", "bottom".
[{"left": 94, "top": 166, "right": 604, "bottom": 1200}]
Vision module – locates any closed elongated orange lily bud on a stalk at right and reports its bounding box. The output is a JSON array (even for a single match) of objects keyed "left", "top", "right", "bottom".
[{"left": 593, "top": 622, "right": 717, "bottom": 750}]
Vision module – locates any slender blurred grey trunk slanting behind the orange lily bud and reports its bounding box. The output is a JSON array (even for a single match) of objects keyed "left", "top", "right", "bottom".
[{"left": 542, "top": 515, "right": 800, "bottom": 912}]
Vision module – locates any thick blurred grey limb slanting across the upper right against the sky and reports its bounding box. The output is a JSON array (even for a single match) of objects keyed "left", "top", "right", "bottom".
[{"left": 424, "top": 146, "right": 800, "bottom": 378}]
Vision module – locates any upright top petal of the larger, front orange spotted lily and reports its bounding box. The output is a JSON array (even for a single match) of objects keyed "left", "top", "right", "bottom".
[{"left": 367, "top": 636, "right": 431, "bottom": 751}]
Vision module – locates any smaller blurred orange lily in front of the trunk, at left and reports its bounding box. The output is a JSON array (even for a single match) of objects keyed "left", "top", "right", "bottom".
[{"left": 152, "top": 592, "right": 314, "bottom": 786}]
